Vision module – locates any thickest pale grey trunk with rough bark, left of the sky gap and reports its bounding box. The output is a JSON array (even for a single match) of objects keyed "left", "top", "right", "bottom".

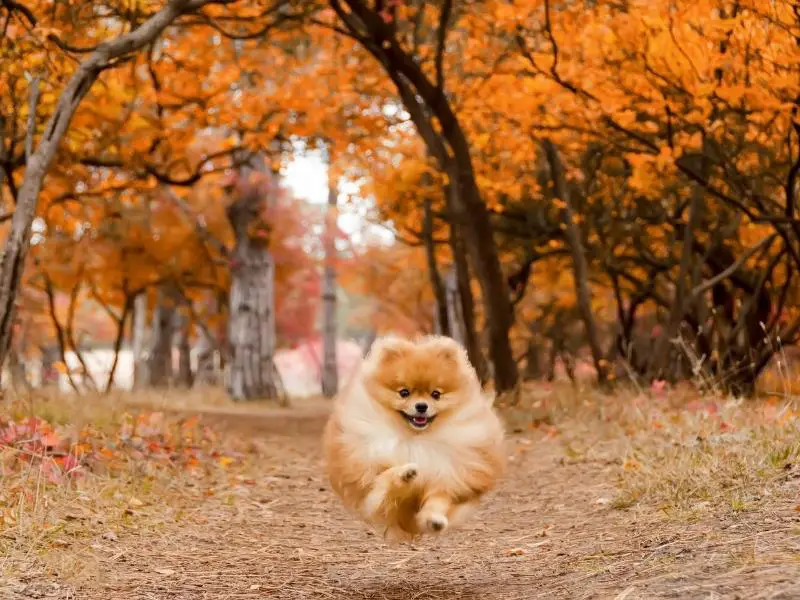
[{"left": 227, "top": 169, "right": 281, "bottom": 400}]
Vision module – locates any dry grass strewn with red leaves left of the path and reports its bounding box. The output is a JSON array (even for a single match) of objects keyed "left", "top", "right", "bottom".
[{"left": 0, "top": 392, "right": 288, "bottom": 578}]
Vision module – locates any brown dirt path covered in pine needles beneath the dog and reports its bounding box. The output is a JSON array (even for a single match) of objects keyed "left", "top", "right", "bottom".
[{"left": 45, "top": 407, "right": 800, "bottom": 600}]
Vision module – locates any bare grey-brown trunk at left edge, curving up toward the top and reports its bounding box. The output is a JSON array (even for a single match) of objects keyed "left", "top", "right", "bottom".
[{"left": 0, "top": 0, "right": 199, "bottom": 365}]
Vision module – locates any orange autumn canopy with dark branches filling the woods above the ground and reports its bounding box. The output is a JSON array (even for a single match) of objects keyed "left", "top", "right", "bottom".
[{"left": 0, "top": 0, "right": 800, "bottom": 394}]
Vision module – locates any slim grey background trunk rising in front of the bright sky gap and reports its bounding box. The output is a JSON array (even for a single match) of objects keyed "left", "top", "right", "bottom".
[{"left": 322, "top": 173, "right": 339, "bottom": 398}]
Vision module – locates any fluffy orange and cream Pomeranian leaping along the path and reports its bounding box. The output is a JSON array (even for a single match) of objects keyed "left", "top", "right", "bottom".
[{"left": 323, "top": 336, "right": 505, "bottom": 541}]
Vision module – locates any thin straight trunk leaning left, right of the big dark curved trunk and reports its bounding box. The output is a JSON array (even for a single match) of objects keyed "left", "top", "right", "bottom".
[{"left": 542, "top": 140, "right": 608, "bottom": 386}]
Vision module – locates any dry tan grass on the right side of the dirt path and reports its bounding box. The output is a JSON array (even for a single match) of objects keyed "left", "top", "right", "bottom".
[{"left": 508, "top": 386, "right": 800, "bottom": 518}]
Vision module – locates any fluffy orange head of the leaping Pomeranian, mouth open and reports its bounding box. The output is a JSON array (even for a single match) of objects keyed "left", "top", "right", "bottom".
[{"left": 365, "top": 336, "right": 480, "bottom": 432}]
